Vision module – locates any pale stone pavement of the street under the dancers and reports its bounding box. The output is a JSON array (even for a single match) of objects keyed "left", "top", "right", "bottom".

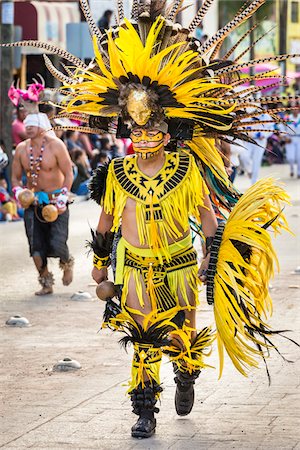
[{"left": 0, "top": 166, "right": 300, "bottom": 450}]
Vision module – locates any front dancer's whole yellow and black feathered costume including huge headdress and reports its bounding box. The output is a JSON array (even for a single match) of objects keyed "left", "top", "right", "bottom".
[{"left": 13, "top": 0, "right": 297, "bottom": 438}]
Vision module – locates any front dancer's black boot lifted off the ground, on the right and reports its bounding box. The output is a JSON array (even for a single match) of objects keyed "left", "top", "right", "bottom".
[{"left": 174, "top": 364, "right": 200, "bottom": 416}]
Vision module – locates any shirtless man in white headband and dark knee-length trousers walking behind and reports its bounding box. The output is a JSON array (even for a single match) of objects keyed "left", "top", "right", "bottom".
[{"left": 12, "top": 113, "right": 74, "bottom": 295}]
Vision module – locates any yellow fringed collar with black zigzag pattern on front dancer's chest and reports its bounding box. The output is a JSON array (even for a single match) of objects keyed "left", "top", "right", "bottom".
[{"left": 103, "top": 152, "right": 209, "bottom": 262}]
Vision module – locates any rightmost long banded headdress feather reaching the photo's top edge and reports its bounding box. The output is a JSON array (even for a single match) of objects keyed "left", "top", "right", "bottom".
[{"left": 199, "top": 0, "right": 265, "bottom": 54}]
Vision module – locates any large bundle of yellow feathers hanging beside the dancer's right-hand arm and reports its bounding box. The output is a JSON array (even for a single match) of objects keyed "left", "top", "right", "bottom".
[{"left": 214, "top": 179, "right": 289, "bottom": 376}]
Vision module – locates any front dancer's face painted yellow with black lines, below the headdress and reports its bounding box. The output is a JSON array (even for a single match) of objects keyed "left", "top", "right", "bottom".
[{"left": 130, "top": 128, "right": 164, "bottom": 159}]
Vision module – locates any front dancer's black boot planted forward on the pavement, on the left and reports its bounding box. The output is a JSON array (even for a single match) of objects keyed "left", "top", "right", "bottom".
[{"left": 130, "top": 381, "right": 162, "bottom": 439}]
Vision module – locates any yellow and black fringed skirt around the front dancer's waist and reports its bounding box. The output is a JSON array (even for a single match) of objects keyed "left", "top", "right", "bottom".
[{"left": 115, "top": 235, "right": 199, "bottom": 314}]
